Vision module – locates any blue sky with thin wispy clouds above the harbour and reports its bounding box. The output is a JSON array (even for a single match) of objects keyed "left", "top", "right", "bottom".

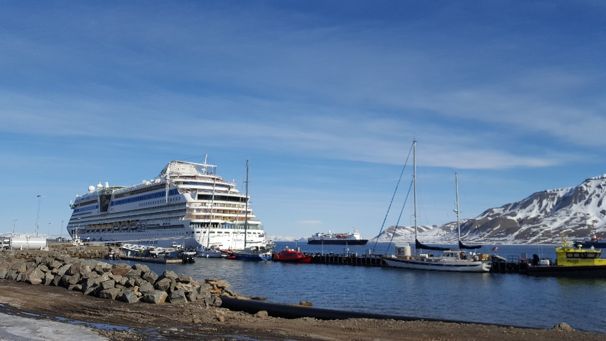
[{"left": 0, "top": 1, "right": 606, "bottom": 237}]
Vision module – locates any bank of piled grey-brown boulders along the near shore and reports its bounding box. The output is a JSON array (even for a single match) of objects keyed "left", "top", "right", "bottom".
[{"left": 0, "top": 252, "right": 236, "bottom": 307}]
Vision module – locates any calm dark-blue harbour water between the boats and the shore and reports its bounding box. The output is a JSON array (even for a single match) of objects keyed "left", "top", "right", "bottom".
[{"left": 114, "top": 242, "right": 606, "bottom": 332}]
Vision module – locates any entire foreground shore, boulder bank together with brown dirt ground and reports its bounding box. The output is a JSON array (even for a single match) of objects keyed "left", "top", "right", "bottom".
[{"left": 0, "top": 246, "right": 603, "bottom": 340}]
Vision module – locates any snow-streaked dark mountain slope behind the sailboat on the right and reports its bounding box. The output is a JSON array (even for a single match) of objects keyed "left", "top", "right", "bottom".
[{"left": 377, "top": 174, "right": 606, "bottom": 243}]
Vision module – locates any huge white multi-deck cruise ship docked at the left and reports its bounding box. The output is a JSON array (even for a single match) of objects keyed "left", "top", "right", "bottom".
[{"left": 67, "top": 161, "right": 267, "bottom": 250}]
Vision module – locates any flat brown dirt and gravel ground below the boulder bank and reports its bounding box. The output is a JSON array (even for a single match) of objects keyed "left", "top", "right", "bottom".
[{"left": 0, "top": 280, "right": 605, "bottom": 340}]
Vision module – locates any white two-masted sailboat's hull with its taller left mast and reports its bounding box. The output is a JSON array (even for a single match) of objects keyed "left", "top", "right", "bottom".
[{"left": 383, "top": 140, "right": 490, "bottom": 272}]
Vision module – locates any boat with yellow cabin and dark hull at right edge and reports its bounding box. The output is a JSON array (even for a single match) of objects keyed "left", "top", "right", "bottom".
[{"left": 527, "top": 241, "right": 606, "bottom": 278}]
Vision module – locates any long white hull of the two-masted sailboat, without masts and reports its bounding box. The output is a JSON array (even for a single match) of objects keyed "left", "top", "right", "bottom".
[{"left": 383, "top": 257, "right": 490, "bottom": 272}]
